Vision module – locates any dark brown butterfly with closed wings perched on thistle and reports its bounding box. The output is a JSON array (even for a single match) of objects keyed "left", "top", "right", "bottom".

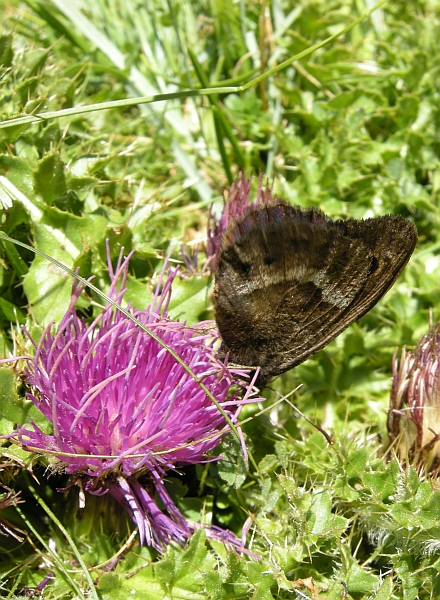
[{"left": 214, "top": 200, "right": 417, "bottom": 387}]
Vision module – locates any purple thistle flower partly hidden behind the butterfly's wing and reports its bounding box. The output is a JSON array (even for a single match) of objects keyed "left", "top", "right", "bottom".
[{"left": 206, "top": 173, "right": 276, "bottom": 273}]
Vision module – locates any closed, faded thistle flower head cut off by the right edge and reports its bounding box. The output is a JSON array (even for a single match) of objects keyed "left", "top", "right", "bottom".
[{"left": 387, "top": 323, "right": 440, "bottom": 472}]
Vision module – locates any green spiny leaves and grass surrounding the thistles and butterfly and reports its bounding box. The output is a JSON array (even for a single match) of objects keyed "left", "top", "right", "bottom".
[{"left": 0, "top": 0, "right": 440, "bottom": 600}]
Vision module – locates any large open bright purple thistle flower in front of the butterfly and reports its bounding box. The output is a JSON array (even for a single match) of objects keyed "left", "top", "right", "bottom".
[{"left": 16, "top": 250, "right": 253, "bottom": 550}]
